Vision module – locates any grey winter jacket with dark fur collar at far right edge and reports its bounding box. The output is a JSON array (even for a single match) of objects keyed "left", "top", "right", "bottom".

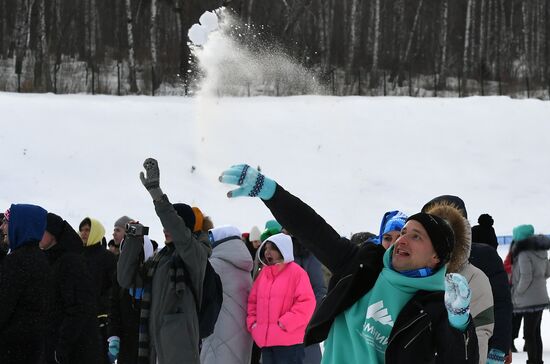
[{"left": 512, "top": 235, "right": 550, "bottom": 313}]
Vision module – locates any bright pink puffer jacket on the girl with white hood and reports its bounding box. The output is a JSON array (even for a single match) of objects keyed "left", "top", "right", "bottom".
[{"left": 246, "top": 262, "right": 315, "bottom": 347}]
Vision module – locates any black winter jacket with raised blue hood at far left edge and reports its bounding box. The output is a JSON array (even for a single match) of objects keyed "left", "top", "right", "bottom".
[{"left": 0, "top": 205, "right": 51, "bottom": 364}]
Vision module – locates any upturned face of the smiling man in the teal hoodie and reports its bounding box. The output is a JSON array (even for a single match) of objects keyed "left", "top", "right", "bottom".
[{"left": 392, "top": 220, "right": 439, "bottom": 272}]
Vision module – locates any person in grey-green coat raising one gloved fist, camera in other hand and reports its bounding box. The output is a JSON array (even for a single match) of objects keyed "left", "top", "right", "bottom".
[{"left": 117, "top": 158, "right": 208, "bottom": 364}]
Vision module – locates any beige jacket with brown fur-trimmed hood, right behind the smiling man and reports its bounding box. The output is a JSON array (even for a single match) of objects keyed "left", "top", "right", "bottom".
[{"left": 425, "top": 203, "right": 495, "bottom": 364}]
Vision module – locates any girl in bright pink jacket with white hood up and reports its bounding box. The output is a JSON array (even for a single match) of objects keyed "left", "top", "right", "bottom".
[{"left": 246, "top": 234, "right": 315, "bottom": 364}]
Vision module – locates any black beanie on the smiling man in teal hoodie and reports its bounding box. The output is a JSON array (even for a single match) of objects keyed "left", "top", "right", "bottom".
[{"left": 407, "top": 212, "right": 455, "bottom": 266}]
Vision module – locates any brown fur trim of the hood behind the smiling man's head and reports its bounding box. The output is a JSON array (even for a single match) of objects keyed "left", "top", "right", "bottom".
[{"left": 424, "top": 201, "right": 472, "bottom": 273}]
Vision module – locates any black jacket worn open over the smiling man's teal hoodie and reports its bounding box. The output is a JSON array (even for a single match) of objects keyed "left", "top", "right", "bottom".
[{"left": 264, "top": 185, "right": 478, "bottom": 364}]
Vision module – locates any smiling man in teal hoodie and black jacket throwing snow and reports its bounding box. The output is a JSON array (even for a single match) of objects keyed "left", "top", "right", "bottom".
[{"left": 220, "top": 165, "right": 478, "bottom": 364}]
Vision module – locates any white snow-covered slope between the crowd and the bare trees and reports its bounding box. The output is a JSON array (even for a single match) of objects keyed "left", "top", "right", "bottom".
[{"left": 0, "top": 93, "right": 550, "bottom": 362}]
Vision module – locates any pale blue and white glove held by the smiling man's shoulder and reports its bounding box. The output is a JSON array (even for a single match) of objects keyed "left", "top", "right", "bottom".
[{"left": 445, "top": 273, "right": 472, "bottom": 331}]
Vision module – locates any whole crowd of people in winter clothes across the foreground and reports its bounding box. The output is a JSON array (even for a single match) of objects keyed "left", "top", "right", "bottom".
[{"left": 0, "top": 158, "right": 550, "bottom": 364}]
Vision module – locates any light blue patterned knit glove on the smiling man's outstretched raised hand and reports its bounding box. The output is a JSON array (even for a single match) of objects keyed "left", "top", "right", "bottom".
[{"left": 219, "top": 164, "right": 277, "bottom": 200}]
